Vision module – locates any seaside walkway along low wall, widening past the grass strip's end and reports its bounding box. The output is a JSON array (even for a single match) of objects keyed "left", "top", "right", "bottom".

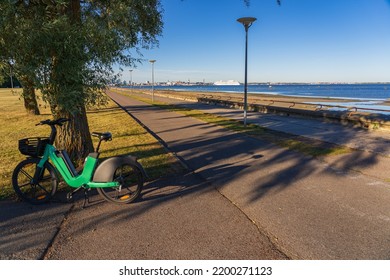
[{"left": 138, "top": 91, "right": 390, "bottom": 181}]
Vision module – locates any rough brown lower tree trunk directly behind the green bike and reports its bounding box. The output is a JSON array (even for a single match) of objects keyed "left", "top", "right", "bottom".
[{"left": 54, "top": 105, "right": 93, "bottom": 166}]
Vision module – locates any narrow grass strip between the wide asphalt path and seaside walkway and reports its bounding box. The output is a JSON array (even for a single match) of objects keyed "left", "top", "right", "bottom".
[{"left": 112, "top": 90, "right": 352, "bottom": 157}]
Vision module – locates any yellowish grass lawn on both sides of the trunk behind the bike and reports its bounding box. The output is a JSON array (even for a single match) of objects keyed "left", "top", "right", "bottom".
[{"left": 0, "top": 89, "right": 182, "bottom": 199}]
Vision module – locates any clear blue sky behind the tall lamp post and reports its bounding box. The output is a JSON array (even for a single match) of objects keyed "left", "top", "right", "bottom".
[{"left": 121, "top": 0, "right": 390, "bottom": 83}]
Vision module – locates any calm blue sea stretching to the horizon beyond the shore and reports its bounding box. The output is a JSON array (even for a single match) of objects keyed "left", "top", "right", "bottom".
[{"left": 142, "top": 83, "right": 390, "bottom": 101}]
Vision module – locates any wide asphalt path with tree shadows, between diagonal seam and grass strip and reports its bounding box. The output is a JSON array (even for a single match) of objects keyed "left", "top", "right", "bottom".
[{"left": 104, "top": 92, "right": 390, "bottom": 259}]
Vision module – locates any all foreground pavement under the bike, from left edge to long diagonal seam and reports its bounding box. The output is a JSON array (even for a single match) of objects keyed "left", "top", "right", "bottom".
[{"left": 0, "top": 172, "right": 287, "bottom": 260}]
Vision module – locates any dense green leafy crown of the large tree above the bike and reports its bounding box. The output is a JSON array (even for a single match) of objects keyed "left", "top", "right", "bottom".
[{"left": 0, "top": 0, "right": 162, "bottom": 113}]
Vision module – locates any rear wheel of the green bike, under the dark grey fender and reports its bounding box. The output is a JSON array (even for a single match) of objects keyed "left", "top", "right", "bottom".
[{"left": 97, "top": 162, "right": 144, "bottom": 204}]
